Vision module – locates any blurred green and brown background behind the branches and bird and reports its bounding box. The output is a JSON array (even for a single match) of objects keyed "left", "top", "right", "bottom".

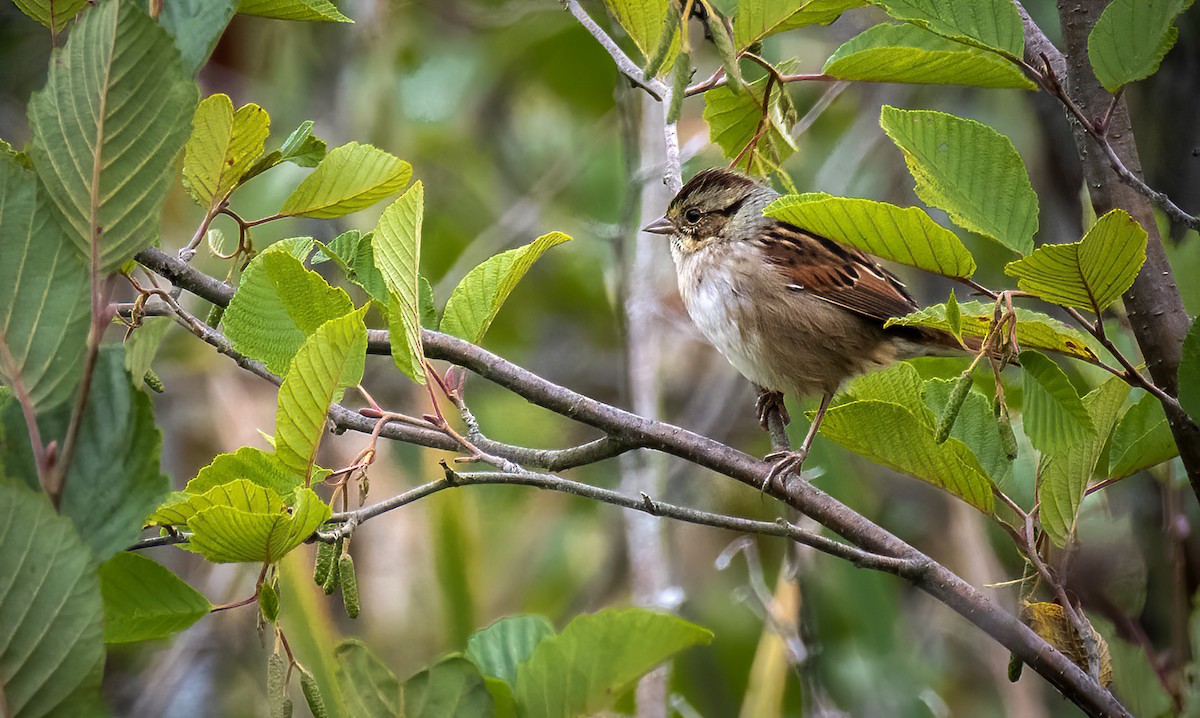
[{"left": 0, "top": 0, "right": 1200, "bottom": 718}]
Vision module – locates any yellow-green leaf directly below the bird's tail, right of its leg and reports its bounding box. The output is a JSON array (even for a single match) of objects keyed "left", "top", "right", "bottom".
[{"left": 821, "top": 401, "right": 992, "bottom": 514}]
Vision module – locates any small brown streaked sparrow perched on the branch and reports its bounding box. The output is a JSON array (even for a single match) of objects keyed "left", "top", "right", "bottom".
[{"left": 642, "top": 169, "right": 961, "bottom": 481}]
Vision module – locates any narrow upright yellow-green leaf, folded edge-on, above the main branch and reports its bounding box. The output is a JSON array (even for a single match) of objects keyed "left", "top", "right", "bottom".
[{"left": 371, "top": 183, "right": 425, "bottom": 384}]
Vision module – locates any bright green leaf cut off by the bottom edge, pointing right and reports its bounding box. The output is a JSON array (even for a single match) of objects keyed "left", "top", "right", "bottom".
[{"left": 514, "top": 609, "right": 713, "bottom": 718}]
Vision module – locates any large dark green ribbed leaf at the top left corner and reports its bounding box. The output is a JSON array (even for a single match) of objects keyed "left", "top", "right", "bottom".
[{"left": 29, "top": 1, "right": 197, "bottom": 274}]
